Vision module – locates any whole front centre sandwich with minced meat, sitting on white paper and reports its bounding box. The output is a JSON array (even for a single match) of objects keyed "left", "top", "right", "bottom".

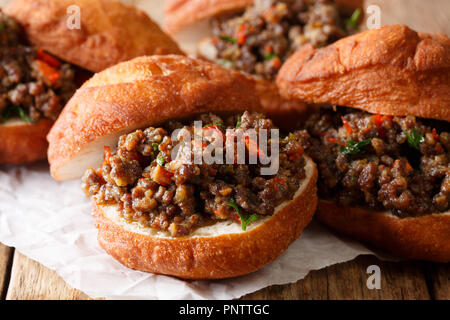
[{"left": 48, "top": 55, "right": 317, "bottom": 279}]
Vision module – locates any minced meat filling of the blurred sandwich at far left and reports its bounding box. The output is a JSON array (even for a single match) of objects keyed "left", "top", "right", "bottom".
[{"left": 0, "top": 11, "right": 76, "bottom": 123}]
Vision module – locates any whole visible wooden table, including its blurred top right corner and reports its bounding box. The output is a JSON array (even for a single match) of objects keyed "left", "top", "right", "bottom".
[{"left": 0, "top": 0, "right": 450, "bottom": 300}]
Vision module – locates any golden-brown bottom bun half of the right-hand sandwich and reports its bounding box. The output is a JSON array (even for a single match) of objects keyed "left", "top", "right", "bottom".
[{"left": 316, "top": 200, "right": 450, "bottom": 262}]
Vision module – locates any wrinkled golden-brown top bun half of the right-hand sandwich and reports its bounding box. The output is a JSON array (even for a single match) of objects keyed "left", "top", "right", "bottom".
[{"left": 277, "top": 25, "right": 450, "bottom": 121}]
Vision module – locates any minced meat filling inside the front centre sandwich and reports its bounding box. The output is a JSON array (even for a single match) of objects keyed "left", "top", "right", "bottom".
[{"left": 82, "top": 112, "right": 305, "bottom": 236}]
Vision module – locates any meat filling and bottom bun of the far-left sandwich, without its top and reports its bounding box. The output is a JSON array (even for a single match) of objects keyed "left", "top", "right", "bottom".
[{"left": 0, "top": 12, "right": 76, "bottom": 164}]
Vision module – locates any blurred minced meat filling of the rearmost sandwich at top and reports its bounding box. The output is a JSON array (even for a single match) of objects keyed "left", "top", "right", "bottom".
[{"left": 212, "top": 0, "right": 358, "bottom": 80}]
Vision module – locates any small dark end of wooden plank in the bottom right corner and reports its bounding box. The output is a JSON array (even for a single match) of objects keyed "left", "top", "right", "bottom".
[{"left": 426, "top": 263, "right": 450, "bottom": 300}]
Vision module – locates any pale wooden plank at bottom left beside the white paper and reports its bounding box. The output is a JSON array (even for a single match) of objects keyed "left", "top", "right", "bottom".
[{"left": 6, "top": 251, "right": 89, "bottom": 300}]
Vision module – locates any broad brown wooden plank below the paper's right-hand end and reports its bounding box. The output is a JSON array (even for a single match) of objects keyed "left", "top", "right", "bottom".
[{"left": 243, "top": 256, "right": 430, "bottom": 300}]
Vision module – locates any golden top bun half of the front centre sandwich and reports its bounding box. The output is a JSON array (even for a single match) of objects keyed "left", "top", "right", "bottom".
[{"left": 48, "top": 55, "right": 261, "bottom": 180}]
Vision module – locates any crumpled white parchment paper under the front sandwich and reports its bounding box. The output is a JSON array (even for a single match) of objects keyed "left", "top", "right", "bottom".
[{"left": 0, "top": 0, "right": 390, "bottom": 299}]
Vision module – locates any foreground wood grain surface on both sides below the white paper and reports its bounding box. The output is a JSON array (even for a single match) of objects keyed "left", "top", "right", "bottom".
[{"left": 0, "top": 245, "right": 450, "bottom": 300}]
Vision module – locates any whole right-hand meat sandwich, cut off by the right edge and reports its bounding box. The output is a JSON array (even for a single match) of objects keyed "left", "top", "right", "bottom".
[{"left": 278, "top": 25, "right": 450, "bottom": 262}]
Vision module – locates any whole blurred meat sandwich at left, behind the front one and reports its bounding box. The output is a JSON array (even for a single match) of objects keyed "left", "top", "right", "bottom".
[{"left": 0, "top": 0, "right": 181, "bottom": 164}]
